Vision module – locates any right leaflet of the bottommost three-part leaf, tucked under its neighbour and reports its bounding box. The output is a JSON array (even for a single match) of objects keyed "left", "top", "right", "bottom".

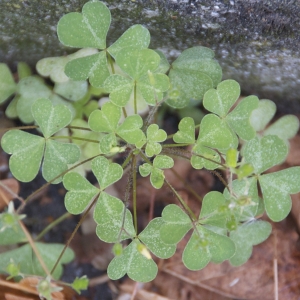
[{"left": 138, "top": 218, "right": 176, "bottom": 259}]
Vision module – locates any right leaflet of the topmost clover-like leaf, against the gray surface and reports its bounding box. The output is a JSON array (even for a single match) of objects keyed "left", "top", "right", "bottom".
[{"left": 107, "top": 25, "right": 150, "bottom": 57}]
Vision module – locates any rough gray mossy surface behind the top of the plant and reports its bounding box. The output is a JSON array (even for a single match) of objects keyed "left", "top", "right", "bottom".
[{"left": 0, "top": 0, "right": 300, "bottom": 113}]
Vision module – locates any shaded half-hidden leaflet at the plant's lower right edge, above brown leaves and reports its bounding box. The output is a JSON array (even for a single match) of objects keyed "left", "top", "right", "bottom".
[{"left": 230, "top": 221, "right": 272, "bottom": 267}]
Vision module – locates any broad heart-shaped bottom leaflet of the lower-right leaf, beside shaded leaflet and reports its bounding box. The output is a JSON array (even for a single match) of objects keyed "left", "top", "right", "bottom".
[{"left": 182, "top": 226, "right": 235, "bottom": 270}]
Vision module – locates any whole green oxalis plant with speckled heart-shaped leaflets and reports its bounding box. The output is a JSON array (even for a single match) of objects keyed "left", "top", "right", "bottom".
[{"left": 0, "top": 1, "right": 300, "bottom": 299}]
